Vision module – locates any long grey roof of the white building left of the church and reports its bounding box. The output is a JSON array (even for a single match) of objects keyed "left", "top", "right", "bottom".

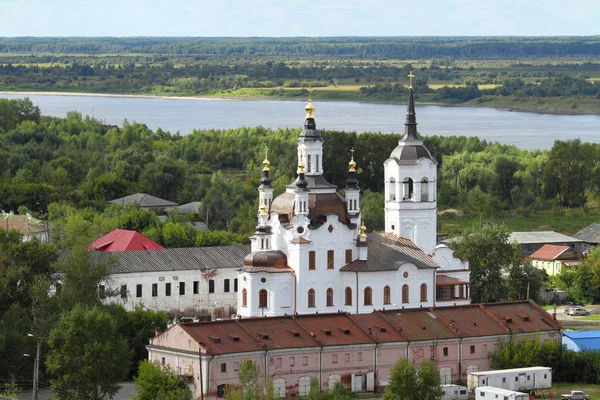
[{"left": 59, "top": 245, "right": 250, "bottom": 274}]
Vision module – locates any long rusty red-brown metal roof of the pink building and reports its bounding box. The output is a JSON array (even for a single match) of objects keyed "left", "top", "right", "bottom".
[{"left": 157, "top": 301, "right": 560, "bottom": 354}]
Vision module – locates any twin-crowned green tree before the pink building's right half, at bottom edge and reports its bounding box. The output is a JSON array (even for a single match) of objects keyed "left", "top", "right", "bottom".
[{"left": 383, "top": 358, "right": 442, "bottom": 400}]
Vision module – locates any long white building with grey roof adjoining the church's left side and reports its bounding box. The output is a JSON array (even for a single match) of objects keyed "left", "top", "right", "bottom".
[{"left": 82, "top": 245, "right": 250, "bottom": 318}]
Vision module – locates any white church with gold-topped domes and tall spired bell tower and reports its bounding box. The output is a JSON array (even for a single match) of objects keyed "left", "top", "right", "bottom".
[{"left": 237, "top": 74, "right": 470, "bottom": 318}]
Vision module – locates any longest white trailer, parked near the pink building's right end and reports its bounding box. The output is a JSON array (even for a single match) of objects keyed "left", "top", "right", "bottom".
[{"left": 467, "top": 367, "right": 552, "bottom": 393}]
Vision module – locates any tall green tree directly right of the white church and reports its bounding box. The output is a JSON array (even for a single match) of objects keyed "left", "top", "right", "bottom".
[{"left": 452, "top": 224, "right": 521, "bottom": 303}]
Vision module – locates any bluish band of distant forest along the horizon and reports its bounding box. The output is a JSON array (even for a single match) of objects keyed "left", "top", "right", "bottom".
[{"left": 0, "top": 36, "right": 600, "bottom": 59}]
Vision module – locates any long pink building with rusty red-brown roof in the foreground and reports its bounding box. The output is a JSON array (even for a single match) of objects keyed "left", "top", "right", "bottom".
[{"left": 148, "top": 301, "right": 560, "bottom": 398}]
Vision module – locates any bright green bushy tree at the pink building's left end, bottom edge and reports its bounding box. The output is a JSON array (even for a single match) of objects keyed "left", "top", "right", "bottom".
[{"left": 133, "top": 360, "right": 193, "bottom": 400}]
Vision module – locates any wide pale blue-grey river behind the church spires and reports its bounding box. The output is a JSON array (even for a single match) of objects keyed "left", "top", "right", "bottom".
[{"left": 0, "top": 93, "right": 600, "bottom": 149}]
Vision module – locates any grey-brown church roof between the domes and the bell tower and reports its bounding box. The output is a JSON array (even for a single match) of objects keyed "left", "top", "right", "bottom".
[{"left": 340, "top": 233, "right": 439, "bottom": 272}]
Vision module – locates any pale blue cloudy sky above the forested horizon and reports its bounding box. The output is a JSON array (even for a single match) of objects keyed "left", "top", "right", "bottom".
[{"left": 0, "top": 0, "right": 600, "bottom": 37}]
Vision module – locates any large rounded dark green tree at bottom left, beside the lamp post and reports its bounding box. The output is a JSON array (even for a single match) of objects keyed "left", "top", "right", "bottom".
[{"left": 46, "top": 305, "right": 131, "bottom": 400}]
